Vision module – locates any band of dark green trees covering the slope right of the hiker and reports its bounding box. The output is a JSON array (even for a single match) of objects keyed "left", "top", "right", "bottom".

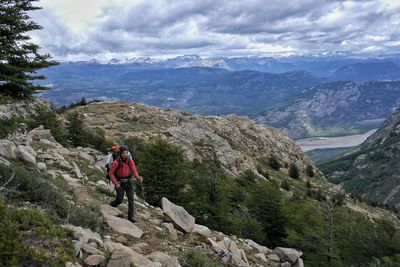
[{"left": 129, "top": 138, "right": 400, "bottom": 266}]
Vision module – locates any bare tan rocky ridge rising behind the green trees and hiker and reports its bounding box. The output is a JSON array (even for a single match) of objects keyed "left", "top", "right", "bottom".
[{"left": 71, "top": 102, "right": 323, "bottom": 177}]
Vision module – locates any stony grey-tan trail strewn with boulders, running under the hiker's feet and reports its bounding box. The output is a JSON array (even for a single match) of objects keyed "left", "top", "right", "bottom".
[{"left": 0, "top": 127, "right": 303, "bottom": 267}]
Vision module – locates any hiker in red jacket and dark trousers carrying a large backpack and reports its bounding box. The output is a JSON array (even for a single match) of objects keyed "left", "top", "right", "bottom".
[{"left": 108, "top": 146, "right": 143, "bottom": 222}]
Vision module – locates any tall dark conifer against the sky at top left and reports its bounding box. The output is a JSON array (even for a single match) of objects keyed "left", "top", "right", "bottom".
[{"left": 0, "top": 0, "right": 57, "bottom": 98}]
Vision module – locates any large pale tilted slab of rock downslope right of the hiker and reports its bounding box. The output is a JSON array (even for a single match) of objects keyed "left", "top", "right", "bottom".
[{"left": 161, "top": 197, "right": 195, "bottom": 233}]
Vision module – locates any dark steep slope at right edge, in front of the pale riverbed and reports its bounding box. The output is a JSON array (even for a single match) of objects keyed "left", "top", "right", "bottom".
[{"left": 321, "top": 110, "right": 400, "bottom": 210}]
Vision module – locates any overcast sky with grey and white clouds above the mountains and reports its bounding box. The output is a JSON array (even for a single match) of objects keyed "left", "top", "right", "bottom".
[{"left": 30, "top": 0, "right": 400, "bottom": 60}]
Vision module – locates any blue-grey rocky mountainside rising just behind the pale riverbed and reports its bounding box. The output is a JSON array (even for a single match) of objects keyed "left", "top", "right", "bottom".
[{"left": 254, "top": 82, "right": 400, "bottom": 139}]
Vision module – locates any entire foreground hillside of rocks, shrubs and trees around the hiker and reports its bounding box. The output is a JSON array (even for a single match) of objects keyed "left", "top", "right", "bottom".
[{"left": 0, "top": 101, "right": 400, "bottom": 267}]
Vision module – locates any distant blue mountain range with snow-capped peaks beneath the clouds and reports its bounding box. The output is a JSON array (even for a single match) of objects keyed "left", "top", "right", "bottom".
[{"left": 36, "top": 54, "right": 400, "bottom": 138}]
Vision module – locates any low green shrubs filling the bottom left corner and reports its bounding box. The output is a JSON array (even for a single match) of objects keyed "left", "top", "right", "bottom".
[{"left": 0, "top": 200, "right": 74, "bottom": 266}]
